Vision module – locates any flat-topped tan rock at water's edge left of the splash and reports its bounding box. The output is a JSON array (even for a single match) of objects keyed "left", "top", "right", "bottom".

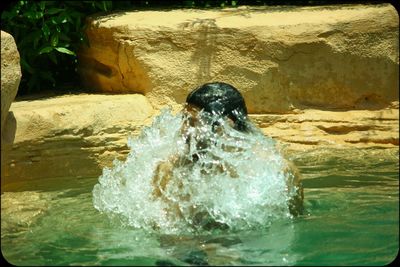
[{"left": 1, "top": 94, "right": 154, "bottom": 191}]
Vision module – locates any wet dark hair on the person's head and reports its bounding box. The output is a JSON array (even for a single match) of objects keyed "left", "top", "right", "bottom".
[{"left": 186, "top": 82, "right": 248, "bottom": 132}]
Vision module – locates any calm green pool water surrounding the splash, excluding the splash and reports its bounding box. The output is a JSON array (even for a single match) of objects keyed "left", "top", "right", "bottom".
[{"left": 1, "top": 148, "right": 399, "bottom": 265}]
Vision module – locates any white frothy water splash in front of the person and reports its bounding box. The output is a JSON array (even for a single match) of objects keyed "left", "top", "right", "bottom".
[{"left": 93, "top": 109, "right": 295, "bottom": 233}]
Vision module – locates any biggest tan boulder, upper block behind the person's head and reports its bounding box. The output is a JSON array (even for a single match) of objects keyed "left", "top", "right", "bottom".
[{"left": 79, "top": 4, "right": 399, "bottom": 113}]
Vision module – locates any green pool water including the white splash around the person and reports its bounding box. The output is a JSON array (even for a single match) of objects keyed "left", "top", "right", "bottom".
[{"left": 1, "top": 109, "right": 399, "bottom": 266}]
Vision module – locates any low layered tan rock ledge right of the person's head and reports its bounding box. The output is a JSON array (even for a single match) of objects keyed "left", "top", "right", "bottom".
[{"left": 250, "top": 102, "right": 399, "bottom": 150}]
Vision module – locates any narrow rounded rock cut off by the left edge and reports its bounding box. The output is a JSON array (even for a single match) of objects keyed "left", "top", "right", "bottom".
[{"left": 1, "top": 31, "right": 21, "bottom": 134}]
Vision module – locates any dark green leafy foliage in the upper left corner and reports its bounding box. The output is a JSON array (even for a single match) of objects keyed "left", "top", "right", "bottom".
[{"left": 1, "top": 1, "right": 112, "bottom": 94}]
